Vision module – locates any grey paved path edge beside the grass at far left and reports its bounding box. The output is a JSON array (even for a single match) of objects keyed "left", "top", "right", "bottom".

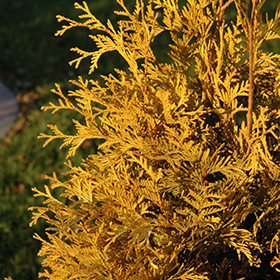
[{"left": 0, "top": 82, "right": 18, "bottom": 138}]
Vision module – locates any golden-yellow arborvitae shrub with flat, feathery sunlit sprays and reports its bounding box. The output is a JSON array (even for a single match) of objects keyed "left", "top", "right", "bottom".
[{"left": 31, "top": 0, "right": 280, "bottom": 280}]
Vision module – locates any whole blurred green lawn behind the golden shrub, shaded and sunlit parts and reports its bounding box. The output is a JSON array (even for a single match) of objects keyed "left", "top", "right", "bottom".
[{"left": 0, "top": 0, "right": 279, "bottom": 280}]
